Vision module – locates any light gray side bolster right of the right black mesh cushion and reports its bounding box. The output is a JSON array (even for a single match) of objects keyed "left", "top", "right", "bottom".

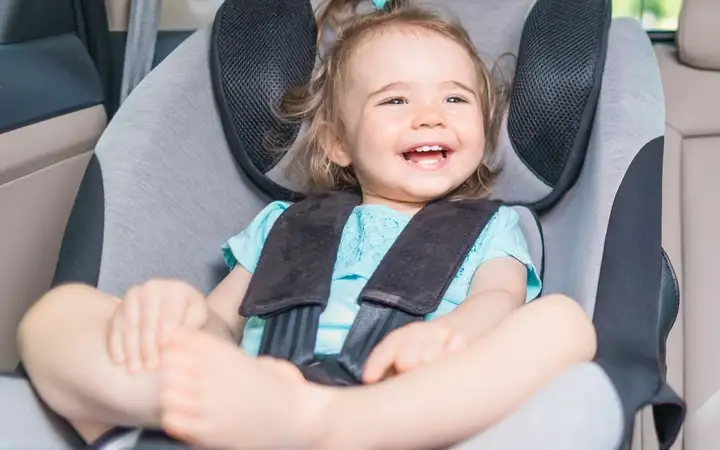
[{"left": 542, "top": 19, "right": 665, "bottom": 314}]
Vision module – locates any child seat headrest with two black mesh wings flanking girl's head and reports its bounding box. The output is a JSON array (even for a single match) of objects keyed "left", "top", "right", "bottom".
[{"left": 211, "top": 0, "right": 611, "bottom": 213}]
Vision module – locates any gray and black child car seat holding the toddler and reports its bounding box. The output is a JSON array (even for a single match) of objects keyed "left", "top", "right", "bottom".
[{"left": 0, "top": 0, "right": 684, "bottom": 450}]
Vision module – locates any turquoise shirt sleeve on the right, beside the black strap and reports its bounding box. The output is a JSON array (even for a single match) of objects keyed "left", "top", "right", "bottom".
[{"left": 477, "top": 206, "right": 542, "bottom": 302}]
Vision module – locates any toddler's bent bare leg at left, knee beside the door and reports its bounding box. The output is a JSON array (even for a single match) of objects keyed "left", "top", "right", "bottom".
[{"left": 18, "top": 285, "right": 159, "bottom": 441}]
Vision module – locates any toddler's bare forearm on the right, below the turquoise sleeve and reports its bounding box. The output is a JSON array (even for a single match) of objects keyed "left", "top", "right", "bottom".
[{"left": 436, "top": 257, "right": 527, "bottom": 341}]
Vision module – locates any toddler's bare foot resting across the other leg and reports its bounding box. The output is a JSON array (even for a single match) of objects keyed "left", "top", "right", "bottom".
[{"left": 160, "top": 332, "right": 332, "bottom": 449}]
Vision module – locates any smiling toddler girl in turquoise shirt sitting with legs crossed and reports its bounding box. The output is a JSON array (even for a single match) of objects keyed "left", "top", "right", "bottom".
[{"left": 18, "top": 0, "right": 596, "bottom": 449}]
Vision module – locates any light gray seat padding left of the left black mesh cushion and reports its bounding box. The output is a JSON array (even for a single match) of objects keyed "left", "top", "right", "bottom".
[{"left": 96, "top": 27, "right": 269, "bottom": 295}]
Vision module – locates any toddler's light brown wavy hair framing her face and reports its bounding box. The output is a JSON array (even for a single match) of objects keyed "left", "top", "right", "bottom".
[{"left": 279, "top": 0, "right": 502, "bottom": 199}]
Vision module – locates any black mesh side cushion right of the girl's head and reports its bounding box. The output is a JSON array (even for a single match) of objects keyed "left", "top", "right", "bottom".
[{"left": 508, "top": 0, "right": 612, "bottom": 212}]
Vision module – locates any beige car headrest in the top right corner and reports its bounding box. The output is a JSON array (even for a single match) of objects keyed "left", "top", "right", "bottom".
[{"left": 677, "top": 0, "right": 720, "bottom": 70}]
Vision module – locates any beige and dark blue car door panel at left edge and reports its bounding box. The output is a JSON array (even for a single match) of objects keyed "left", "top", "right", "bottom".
[{"left": 0, "top": 0, "right": 107, "bottom": 371}]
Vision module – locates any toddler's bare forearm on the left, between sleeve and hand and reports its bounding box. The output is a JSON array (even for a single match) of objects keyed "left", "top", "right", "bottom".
[{"left": 204, "top": 264, "right": 252, "bottom": 342}]
